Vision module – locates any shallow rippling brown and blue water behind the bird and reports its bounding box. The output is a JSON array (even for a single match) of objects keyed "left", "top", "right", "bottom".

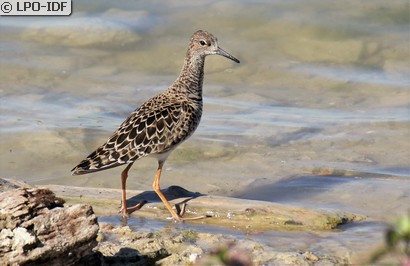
[{"left": 0, "top": 0, "right": 410, "bottom": 262}]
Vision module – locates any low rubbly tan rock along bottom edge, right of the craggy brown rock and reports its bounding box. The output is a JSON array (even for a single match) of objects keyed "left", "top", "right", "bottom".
[{"left": 95, "top": 223, "right": 347, "bottom": 265}]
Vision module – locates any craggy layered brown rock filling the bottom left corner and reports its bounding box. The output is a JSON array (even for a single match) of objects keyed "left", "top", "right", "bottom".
[{"left": 0, "top": 188, "right": 99, "bottom": 265}]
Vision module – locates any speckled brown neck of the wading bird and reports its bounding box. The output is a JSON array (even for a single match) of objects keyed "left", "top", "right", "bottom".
[{"left": 176, "top": 51, "right": 205, "bottom": 100}]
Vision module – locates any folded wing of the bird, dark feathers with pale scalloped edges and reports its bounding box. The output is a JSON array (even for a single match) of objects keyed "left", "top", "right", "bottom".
[{"left": 71, "top": 102, "right": 193, "bottom": 175}]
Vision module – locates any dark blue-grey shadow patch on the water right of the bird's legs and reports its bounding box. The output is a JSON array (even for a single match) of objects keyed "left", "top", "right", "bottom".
[{"left": 234, "top": 176, "right": 355, "bottom": 202}]
